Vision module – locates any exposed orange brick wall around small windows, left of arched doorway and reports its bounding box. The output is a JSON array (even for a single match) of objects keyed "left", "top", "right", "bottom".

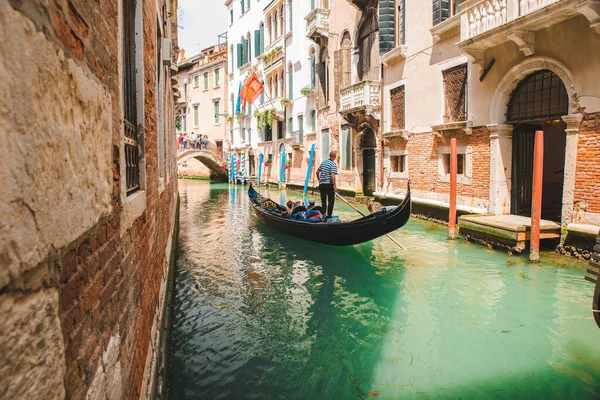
[{"left": 384, "top": 128, "right": 490, "bottom": 200}]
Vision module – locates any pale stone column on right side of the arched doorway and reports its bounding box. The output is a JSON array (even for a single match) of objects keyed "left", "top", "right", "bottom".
[{"left": 561, "top": 114, "right": 583, "bottom": 228}]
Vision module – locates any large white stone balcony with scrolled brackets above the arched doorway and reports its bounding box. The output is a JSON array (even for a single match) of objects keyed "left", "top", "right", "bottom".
[{"left": 458, "top": 0, "right": 600, "bottom": 68}]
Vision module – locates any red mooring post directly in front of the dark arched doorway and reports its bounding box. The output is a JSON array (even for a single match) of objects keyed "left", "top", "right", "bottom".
[{"left": 529, "top": 131, "right": 544, "bottom": 262}]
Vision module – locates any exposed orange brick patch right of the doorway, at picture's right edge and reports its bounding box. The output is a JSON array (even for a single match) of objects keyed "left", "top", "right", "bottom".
[{"left": 574, "top": 113, "right": 600, "bottom": 214}]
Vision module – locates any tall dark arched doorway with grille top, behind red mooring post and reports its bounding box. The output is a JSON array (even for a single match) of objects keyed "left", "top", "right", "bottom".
[{"left": 506, "top": 69, "right": 569, "bottom": 221}]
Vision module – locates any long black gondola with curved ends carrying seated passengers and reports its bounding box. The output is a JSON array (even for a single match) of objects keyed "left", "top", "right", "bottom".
[{"left": 248, "top": 184, "right": 411, "bottom": 246}]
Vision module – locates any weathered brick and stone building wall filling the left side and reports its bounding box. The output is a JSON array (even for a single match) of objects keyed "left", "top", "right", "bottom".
[{"left": 0, "top": 0, "right": 182, "bottom": 399}]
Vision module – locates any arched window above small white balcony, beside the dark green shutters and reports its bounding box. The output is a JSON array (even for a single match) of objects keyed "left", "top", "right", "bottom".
[{"left": 358, "top": 13, "right": 379, "bottom": 81}]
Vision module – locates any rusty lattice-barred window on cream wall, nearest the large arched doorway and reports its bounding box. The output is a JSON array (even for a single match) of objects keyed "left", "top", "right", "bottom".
[{"left": 442, "top": 64, "right": 467, "bottom": 122}]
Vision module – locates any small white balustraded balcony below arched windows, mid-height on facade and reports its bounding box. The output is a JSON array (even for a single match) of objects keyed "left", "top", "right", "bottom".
[{"left": 340, "top": 81, "right": 381, "bottom": 119}]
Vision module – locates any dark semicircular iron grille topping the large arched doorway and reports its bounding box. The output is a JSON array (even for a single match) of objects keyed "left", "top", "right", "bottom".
[{"left": 506, "top": 70, "right": 569, "bottom": 122}]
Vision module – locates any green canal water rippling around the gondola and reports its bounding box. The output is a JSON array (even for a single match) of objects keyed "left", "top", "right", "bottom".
[{"left": 171, "top": 181, "right": 600, "bottom": 399}]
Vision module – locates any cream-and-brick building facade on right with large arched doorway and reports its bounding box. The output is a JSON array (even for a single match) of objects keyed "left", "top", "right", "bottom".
[{"left": 379, "top": 0, "right": 600, "bottom": 238}]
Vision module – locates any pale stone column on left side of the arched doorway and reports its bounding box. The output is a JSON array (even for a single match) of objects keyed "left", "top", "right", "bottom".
[{"left": 487, "top": 124, "right": 513, "bottom": 214}]
